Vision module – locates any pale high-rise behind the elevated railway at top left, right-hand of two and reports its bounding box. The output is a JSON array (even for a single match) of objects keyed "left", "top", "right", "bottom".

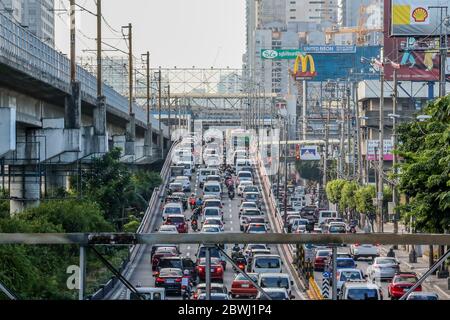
[{"left": 22, "top": 0, "right": 55, "bottom": 47}]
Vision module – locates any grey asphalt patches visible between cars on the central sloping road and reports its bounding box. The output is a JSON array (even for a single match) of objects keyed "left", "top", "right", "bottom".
[{"left": 115, "top": 138, "right": 305, "bottom": 300}]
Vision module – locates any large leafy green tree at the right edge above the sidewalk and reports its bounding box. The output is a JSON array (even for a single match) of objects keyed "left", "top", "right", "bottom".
[{"left": 398, "top": 96, "right": 450, "bottom": 233}]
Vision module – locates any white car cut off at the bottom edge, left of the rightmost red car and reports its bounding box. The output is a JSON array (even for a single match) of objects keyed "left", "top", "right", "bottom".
[{"left": 338, "top": 281, "right": 383, "bottom": 300}]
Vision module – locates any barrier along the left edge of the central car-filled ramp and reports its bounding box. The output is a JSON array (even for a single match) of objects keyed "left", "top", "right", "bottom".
[{"left": 90, "top": 144, "right": 176, "bottom": 300}]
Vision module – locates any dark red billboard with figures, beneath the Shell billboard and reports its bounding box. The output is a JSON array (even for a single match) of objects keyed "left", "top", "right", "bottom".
[{"left": 384, "top": 0, "right": 442, "bottom": 81}]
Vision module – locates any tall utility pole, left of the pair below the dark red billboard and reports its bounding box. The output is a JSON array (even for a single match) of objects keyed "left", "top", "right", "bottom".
[{"left": 377, "top": 48, "right": 384, "bottom": 232}]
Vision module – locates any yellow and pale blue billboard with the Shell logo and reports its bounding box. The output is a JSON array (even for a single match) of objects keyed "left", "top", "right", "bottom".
[{"left": 390, "top": 0, "right": 450, "bottom": 37}]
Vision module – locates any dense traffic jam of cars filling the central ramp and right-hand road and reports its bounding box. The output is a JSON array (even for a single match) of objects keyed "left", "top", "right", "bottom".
[{"left": 128, "top": 131, "right": 439, "bottom": 300}]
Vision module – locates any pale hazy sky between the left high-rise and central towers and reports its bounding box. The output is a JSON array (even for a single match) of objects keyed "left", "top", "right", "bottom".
[{"left": 55, "top": 0, "right": 245, "bottom": 68}]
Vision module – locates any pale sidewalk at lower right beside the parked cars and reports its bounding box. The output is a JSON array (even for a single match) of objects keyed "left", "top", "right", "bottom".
[{"left": 381, "top": 223, "right": 450, "bottom": 300}]
